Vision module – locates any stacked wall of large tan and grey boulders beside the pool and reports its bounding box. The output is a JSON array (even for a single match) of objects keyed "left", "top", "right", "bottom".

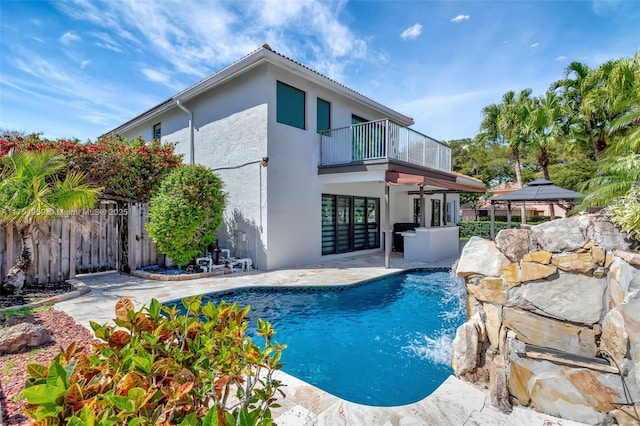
[{"left": 452, "top": 215, "right": 640, "bottom": 425}]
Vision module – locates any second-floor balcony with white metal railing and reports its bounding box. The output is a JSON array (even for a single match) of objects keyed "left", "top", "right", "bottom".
[{"left": 320, "top": 119, "right": 451, "bottom": 173}]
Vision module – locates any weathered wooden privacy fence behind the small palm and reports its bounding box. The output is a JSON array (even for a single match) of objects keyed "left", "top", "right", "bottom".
[{"left": 0, "top": 200, "right": 157, "bottom": 283}]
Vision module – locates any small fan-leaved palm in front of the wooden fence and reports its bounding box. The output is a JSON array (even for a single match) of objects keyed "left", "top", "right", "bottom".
[{"left": 0, "top": 150, "right": 100, "bottom": 293}]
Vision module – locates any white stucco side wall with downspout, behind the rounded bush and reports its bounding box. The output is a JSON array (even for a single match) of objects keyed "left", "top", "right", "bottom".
[{"left": 123, "top": 67, "right": 269, "bottom": 269}]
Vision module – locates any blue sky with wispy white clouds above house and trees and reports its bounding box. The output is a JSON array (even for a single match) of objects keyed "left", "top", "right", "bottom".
[{"left": 0, "top": 0, "right": 640, "bottom": 140}]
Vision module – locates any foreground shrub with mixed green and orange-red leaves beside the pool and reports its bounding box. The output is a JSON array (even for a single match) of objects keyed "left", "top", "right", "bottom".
[{"left": 22, "top": 296, "right": 285, "bottom": 426}]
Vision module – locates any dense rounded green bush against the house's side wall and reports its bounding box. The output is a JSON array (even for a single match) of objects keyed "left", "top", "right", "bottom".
[{"left": 147, "top": 165, "right": 225, "bottom": 266}]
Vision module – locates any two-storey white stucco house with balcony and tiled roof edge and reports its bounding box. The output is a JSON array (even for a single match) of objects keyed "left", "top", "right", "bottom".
[{"left": 103, "top": 45, "right": 484, "bottom": 269}]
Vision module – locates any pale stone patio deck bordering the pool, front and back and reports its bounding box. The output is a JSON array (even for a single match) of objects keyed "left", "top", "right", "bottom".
[{"left": 55, "top": 253, "right": 580, "bottom": 426}]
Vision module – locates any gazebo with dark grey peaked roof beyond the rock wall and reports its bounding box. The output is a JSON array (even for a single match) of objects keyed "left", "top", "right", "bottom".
[{"left": 489, "top": 179, "right": 582, "bottom": 240}]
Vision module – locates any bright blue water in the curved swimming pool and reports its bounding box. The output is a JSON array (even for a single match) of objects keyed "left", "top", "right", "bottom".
[{"left": 175, "top": 270, "right": 465, "bottom": 406}]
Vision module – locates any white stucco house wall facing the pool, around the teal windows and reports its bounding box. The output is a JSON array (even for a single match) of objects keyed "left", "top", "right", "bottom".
[{"left": 267, "top": 66, "right": 398, "bottom": 269}]
